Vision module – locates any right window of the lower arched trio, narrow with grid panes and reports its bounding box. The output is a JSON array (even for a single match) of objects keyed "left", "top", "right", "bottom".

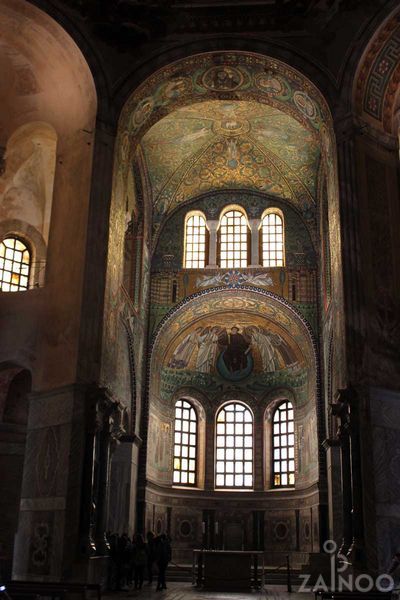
[{"left": 272, "top": 401, "right": 295, "bottom": 487}]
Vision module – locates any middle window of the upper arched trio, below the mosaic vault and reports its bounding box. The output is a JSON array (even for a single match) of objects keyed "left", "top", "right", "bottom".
[{"left": 219, "top": 207, "right": 249, "bottom": 269}]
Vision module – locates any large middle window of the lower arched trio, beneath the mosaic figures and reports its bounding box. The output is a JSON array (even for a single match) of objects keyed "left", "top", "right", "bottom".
[{"left": 215, "top": 402, "right": 253, "bottom": 488}]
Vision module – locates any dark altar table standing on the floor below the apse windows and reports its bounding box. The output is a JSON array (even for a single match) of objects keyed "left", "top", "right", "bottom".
[{"left": 193, "top": 550, "right": 264, "bottom": 592}]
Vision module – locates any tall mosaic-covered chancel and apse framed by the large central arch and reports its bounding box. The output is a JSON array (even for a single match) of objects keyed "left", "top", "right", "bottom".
[{"left": 103, "top": 52, "right": 339, "bottom": 562}]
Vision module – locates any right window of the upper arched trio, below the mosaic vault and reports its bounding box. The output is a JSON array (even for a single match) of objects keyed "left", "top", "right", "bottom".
[{"left": 261, "top": 208, "right": 285, "bottom": 267}]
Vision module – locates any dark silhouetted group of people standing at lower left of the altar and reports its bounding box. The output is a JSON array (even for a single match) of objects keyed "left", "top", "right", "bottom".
[{"left": 107, "top": 531, "right": 171, "bottom": 591}]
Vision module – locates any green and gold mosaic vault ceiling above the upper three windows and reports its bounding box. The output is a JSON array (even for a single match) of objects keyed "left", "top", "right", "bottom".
[{"left": 141, "top": 100, "right": 320, "bottom": 222}]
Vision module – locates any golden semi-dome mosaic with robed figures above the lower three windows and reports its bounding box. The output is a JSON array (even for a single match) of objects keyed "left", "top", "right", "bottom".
[{"left": 150, "top": 288, "right": 316, "bottom": 402}]
